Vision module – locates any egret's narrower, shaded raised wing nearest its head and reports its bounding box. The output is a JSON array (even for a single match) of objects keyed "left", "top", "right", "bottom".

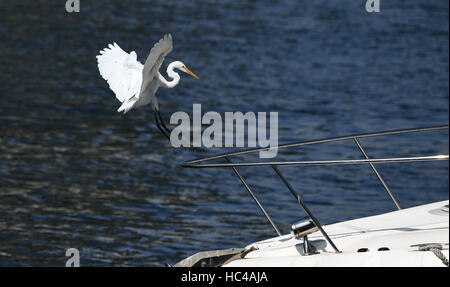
[{"left": 141, "top": 34, "right": 173, "bottom": 91}]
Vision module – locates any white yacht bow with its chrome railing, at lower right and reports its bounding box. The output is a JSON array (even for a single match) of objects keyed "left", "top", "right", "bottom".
[{"left": 175, "top": 125, "right": 449, "bottom": 267}]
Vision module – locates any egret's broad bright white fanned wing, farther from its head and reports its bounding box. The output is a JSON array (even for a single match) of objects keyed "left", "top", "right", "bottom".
[{"left": 97, "top": 43, "right": 144, "bottom": 102}]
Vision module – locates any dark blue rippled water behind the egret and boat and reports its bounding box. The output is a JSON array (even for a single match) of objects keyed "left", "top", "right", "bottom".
[{"left": 0, "top": 0, "right": 449, "bottom": 266}]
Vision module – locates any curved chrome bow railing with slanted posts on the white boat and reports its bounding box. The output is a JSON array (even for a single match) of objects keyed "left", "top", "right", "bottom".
[{"left": 182, "top": 125, "right": 449, "bottom": 252}]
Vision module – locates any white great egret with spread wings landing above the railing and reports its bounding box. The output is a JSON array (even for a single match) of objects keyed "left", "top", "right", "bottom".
[{"left": 97, "top": 34, "right": 198, "bottom": 140}]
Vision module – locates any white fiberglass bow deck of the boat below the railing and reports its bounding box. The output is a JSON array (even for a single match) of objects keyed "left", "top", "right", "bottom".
[{"left": 225, "top": 200, "right": 449, "bottom": 267}]
